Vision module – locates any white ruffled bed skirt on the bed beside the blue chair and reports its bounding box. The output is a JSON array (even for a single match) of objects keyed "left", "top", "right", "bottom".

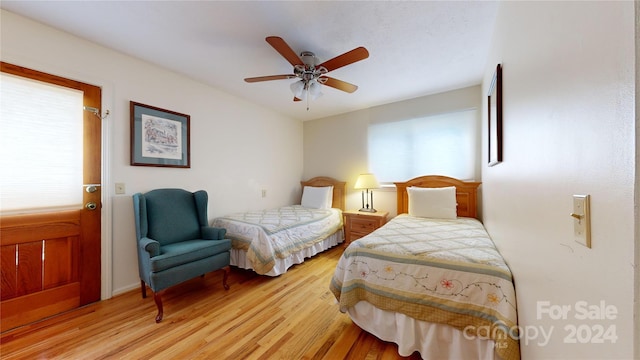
[{"left": 231, "top": 228, "right": 344, "bottom": 276}]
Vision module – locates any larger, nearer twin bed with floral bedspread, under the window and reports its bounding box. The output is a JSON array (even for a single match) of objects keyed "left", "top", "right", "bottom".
[{"left": 330, "top": 176, "right": 520, "bottom": 359}]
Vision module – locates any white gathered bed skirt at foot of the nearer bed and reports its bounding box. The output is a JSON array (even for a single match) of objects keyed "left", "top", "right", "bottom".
[{"left": 347, "top": 301, "right": 496, "bottom": 359}]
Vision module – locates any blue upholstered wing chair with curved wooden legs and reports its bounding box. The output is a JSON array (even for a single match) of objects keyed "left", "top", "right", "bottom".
[{"left": 133, "top": 189, "right": 231, "bottom": 322}]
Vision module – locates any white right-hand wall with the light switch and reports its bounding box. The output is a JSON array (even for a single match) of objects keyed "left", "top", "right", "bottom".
[{"left": 482, "top": 1, "right": 639, "bottom": 359}]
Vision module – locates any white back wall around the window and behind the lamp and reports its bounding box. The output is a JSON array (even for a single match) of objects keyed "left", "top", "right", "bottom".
[{"left": 303, "top": 85, "right": 482, "bottom": 217}]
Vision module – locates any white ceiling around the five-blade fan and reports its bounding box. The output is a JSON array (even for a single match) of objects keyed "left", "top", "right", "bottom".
[{"left": 0, "top": 0, "right": 498, "bottom": 120}]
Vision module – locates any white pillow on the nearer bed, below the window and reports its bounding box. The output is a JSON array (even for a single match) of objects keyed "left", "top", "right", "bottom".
[{"left": 407, "top": 186, "right": 458, "bottom": 219}]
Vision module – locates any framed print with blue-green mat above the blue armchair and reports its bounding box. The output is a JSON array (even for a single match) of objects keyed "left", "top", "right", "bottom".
[{"left": 129, "top": 101, "right": 191, "bottom": 168}]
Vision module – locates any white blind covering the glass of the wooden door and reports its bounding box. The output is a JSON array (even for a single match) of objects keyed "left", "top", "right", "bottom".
[{"left": 0, "top": 73, "right": 83, "bottom": 214}]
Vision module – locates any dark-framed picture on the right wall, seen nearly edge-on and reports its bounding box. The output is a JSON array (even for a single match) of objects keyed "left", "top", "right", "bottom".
[{"left": 487, "top": 64, "right": 502, "bottom": 166}]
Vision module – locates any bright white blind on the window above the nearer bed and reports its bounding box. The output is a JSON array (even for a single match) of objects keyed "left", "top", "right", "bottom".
[{"left": 368, "top": 109, "right": 478, "bottom": 183}]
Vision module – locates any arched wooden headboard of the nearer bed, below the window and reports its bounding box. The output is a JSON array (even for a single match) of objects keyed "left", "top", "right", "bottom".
[{"left": 394, "top": 175, "right": 480, "bottom": 218}]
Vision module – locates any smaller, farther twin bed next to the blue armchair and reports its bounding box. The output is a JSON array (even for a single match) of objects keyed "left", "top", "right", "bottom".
[{"left": 212, "top": 177, "right": 346, "bottom": 276}]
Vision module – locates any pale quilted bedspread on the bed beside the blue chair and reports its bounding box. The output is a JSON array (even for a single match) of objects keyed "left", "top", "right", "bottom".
[{"left": 211, "top": 205, "right": 343, "bottom": 274}]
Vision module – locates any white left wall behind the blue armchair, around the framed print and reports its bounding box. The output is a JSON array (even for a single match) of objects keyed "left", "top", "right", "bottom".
[{"left": 0, "top": 10, "right": 303, "bottom": 298}]
